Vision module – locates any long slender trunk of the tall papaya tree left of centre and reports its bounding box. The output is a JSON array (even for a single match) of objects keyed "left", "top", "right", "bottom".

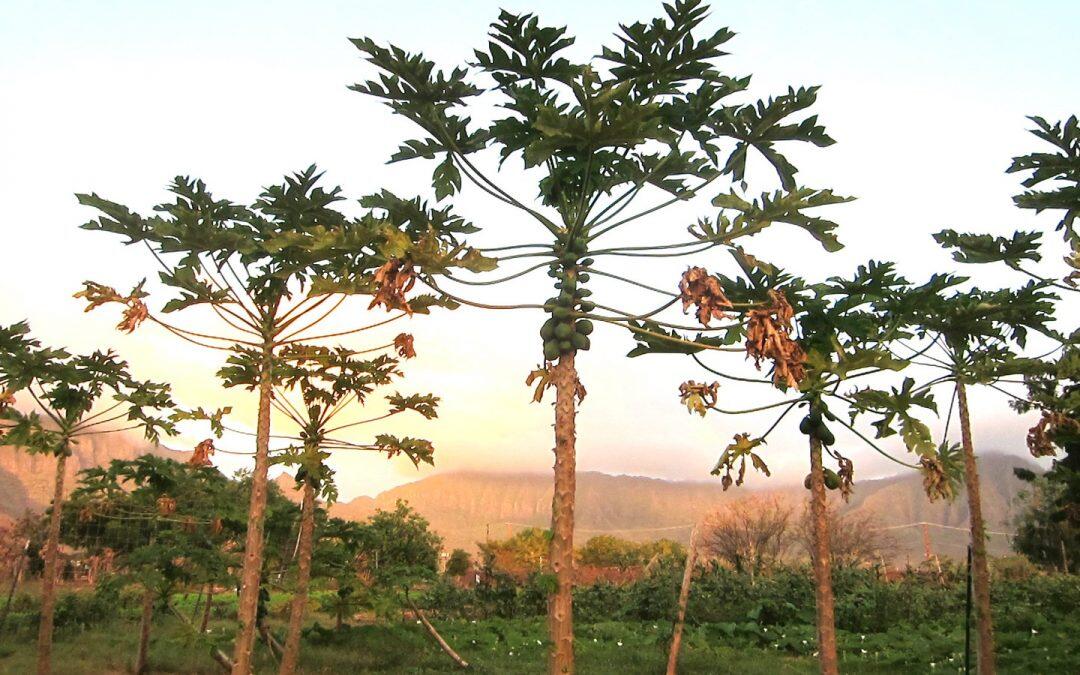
[{"left": 232, "top": 345, "right": 273, "bottom": 675}]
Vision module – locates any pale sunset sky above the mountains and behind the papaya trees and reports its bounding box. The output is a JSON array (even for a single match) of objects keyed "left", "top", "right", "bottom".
[{"left": 0, "top": 0, "right": 1080, "bottom": 498}]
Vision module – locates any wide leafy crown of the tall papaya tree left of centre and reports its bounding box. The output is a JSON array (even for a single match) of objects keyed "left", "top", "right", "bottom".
[{"left": 78, "top": 166, "right": 490, "bottom": 317}]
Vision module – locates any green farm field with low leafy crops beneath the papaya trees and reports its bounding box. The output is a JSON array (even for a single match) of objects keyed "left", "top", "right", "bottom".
[{"left": 0, "top": 570, "right": 1080, "bottom": 674}]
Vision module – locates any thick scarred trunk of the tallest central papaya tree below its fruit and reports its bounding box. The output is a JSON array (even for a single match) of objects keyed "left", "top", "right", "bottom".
[{"left": 548, "top": 352, "right": 578, "bottom": 674}]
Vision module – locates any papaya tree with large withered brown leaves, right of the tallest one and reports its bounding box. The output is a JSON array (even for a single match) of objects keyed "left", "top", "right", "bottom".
[{"left": 631, "top": 259, "right": 948, "bottom": 673}]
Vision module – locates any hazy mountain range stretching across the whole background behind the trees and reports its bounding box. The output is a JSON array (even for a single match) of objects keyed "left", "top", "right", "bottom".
[{"left": 0, "top": 435, "right": 1040, "bottom": 564}]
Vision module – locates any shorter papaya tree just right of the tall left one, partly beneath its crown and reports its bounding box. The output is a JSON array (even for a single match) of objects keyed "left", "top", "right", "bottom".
[{"left": 221, "top": 333, "right": 438, "bottom": 675}]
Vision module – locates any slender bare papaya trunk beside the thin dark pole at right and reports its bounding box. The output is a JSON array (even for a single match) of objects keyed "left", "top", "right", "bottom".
[{"left": 956, "top": 382, "right": 997, "bottom": 675}]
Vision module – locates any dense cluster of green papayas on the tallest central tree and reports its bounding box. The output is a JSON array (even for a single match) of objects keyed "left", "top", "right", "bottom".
[{"left": 540, "top": 238, "right": 596, "bottom": 361}]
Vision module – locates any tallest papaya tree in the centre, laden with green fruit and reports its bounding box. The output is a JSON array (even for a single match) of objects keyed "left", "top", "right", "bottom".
[{"left": 352, "top": 0, "right": 846, "bottom": 673}]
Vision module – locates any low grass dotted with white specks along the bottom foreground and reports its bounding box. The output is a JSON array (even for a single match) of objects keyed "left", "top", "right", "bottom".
[{"left": 0, "top": 595, "right": 1080, "bottom": 675}]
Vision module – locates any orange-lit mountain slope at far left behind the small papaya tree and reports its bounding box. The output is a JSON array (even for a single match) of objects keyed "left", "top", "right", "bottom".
[{"left": 0, "top": 433, "right": 191, "bottom": 519}]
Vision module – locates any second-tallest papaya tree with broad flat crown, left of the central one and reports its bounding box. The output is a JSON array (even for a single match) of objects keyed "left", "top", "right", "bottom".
[{"left": 78, "top": 166, "right": 487, "bottom": 675}]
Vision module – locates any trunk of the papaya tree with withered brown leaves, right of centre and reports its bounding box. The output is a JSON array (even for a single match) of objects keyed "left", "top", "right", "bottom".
[{"left": 810, "top": 436, "right": 839, "bottom": 675}]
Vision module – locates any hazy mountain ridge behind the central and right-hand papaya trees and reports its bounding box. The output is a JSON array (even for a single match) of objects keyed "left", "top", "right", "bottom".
[{"left": 330, "top": 455, "right": 1039, "bottom": 563}]
